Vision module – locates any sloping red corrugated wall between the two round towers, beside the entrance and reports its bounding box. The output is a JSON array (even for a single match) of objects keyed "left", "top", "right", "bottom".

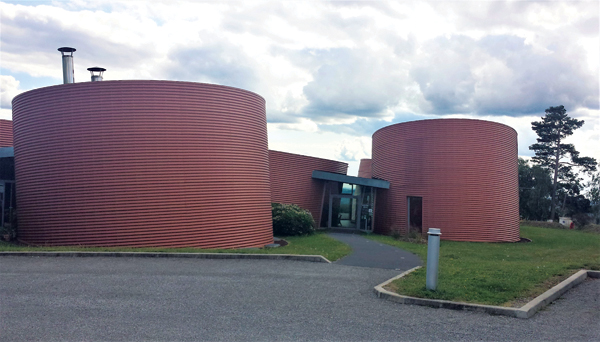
[{"left": 269, "top": 150, "right": 348, "bottom": 225}]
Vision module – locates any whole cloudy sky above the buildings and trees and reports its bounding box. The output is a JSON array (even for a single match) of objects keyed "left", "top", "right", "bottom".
[{"left": 0, "top": 0, "right": 600, "bottom": 175}]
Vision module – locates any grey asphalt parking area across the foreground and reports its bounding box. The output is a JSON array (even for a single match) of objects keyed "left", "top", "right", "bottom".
[{"left": 0, "top": 257, "right": 600, "bottom": 341}]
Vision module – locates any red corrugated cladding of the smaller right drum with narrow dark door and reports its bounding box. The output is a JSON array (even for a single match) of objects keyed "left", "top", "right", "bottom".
[{"left": 372, "top": 119, "right": 519, "bottom": 242}]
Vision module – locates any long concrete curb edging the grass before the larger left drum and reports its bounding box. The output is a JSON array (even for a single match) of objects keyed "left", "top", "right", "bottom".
[{"left": 0, "top": 252, "right": 331, "bottom": 263}]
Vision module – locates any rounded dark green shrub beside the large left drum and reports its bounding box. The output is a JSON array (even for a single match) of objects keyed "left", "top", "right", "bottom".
[{"left": 271, "top": 203, "right": 315, "bottom": 236}]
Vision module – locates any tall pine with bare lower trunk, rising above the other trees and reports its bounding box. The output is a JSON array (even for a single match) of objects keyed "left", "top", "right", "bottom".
[{"left": 529, "top": 106, "right": 597, "bottom": 219}]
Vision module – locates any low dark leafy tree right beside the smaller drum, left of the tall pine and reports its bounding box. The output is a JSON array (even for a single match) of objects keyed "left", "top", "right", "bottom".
[{"left": 519, "top": 158, "right": 552, "bottom": 221}]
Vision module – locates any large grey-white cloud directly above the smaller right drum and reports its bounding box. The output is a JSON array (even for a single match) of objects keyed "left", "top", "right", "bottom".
[{"left": 411, "top": 36, "right": 598, "bottom": 116}]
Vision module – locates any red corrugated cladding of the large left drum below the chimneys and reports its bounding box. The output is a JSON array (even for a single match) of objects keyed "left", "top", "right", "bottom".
[{"left": 13, "top": 81, "right": 273, "bottom": 248}]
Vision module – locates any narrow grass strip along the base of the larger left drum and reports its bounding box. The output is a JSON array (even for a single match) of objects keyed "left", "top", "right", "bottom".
[{"left": 0, "top": 233, "right": 352, "bottom": 261}]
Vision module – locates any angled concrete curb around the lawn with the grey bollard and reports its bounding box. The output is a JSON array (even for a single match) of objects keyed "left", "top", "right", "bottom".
[{"left": 375, "top": 266, "right": 600, "bottom": 318}]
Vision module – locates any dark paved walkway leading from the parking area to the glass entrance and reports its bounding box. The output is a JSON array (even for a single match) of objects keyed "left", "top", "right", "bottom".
[{"left": 328, "top": 233, "right": 423, "bottom": 271}]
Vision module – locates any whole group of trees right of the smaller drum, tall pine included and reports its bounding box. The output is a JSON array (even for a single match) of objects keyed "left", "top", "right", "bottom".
[{"left": 519, "top": 106, "right": 600, "bottom": 225}]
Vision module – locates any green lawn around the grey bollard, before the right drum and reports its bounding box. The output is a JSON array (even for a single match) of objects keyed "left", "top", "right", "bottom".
[{"left": 367, "top": 226, "right": 600, "bottom": 306}]
